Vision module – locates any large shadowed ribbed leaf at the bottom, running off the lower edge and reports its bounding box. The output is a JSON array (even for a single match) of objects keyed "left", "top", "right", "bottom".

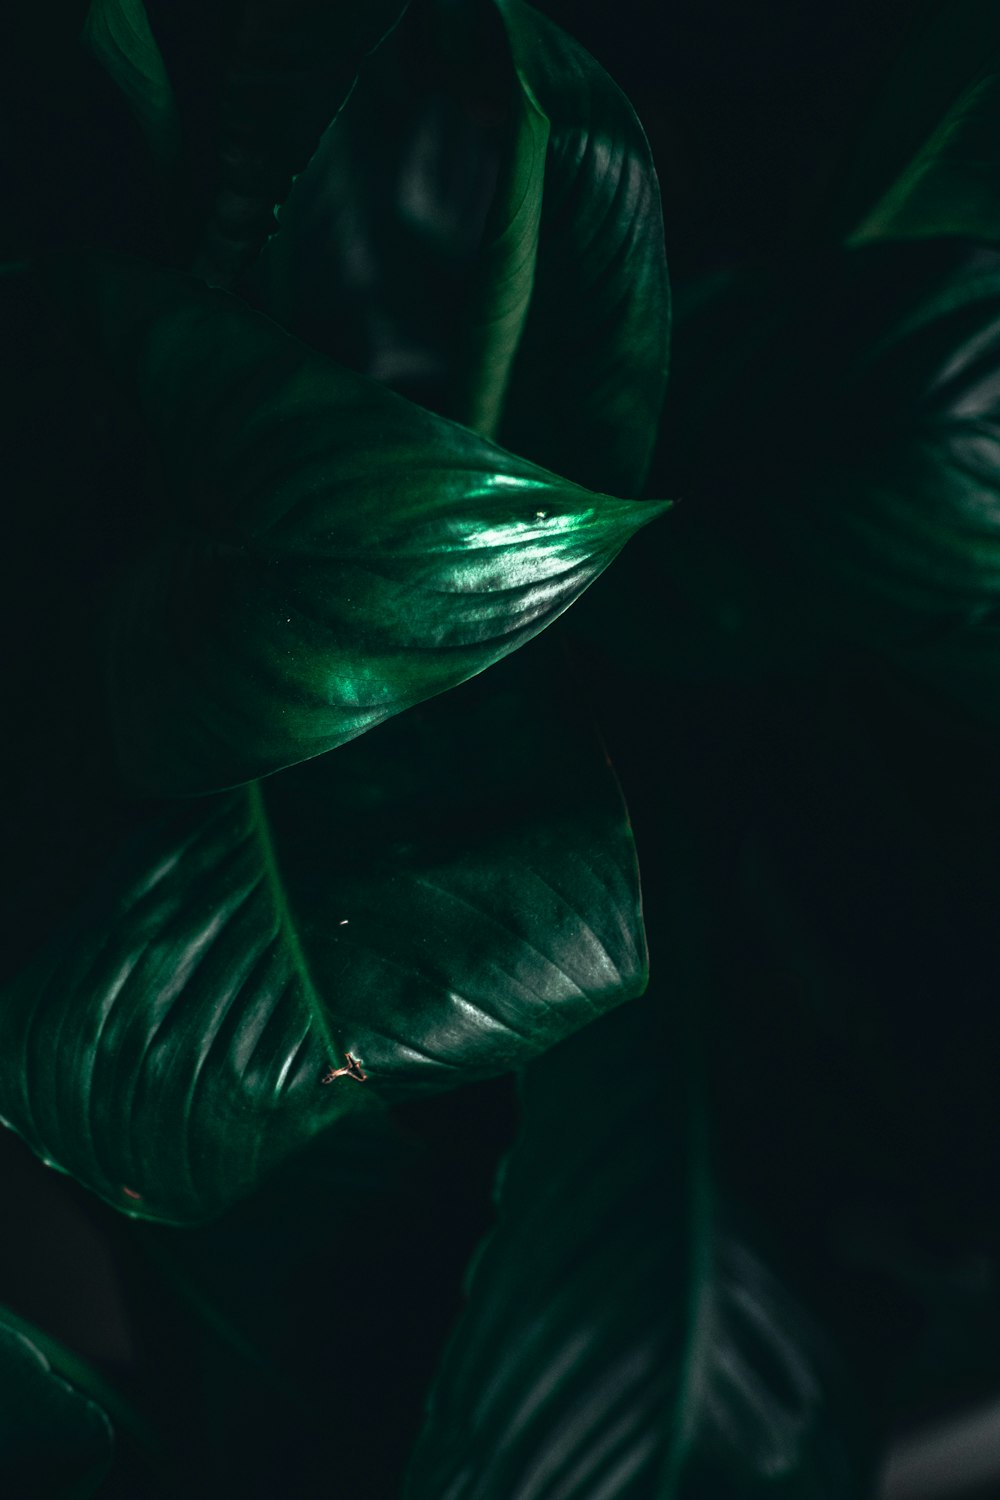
[{"left": 408, "top": 998, "right": 862, "bottom": 1500}]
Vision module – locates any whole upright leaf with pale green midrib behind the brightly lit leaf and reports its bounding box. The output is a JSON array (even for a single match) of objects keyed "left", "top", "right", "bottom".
[{"left": 254, "top": 0, "right": 670, "bottom": 495}]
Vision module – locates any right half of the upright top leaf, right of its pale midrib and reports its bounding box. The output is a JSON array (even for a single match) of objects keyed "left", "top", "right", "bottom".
[{"left": 492, "top": 0, "right": 670, "bottom": 495}]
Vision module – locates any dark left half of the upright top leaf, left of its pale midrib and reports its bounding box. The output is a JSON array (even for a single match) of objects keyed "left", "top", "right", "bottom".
[{"left": 247, "top": 0, "right": 514, "bottom": 399}]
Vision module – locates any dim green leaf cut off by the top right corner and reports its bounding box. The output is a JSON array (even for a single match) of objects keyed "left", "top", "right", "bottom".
[{"left": 844, "top": 0, "right": 1000, "bottom": 243}]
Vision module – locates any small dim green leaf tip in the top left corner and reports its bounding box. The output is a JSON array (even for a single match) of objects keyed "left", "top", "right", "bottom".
[{"left": 82, "top": 0, "right": 180, "bottom": 164}]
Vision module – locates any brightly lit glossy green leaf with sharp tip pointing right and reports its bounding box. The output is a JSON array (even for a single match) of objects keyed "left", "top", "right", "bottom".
[{"left": 37, "top": 260, "right": 664, "bottom": 794}]
